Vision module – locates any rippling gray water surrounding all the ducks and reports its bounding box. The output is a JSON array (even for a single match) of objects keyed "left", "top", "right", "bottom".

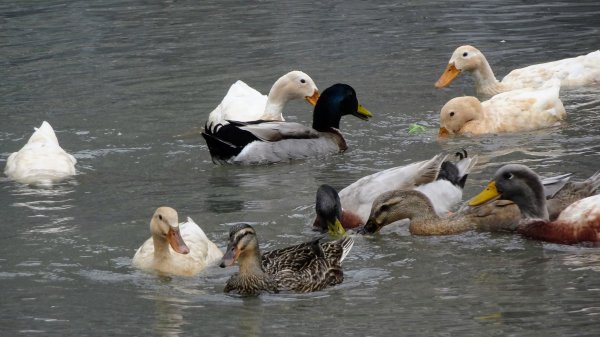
[{"left": 0, "top": 0, "right": 600, "bottom": 336}]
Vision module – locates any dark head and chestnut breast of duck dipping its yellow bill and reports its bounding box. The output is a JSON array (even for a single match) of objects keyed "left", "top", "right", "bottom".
[{"left": 313, "top": 184, "right": 364, "bottom": 235}]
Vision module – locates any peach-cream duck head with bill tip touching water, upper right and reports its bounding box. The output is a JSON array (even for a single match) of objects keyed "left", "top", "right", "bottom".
[{"left": 439, "top": 96, "right": 483, "bottom": 137}]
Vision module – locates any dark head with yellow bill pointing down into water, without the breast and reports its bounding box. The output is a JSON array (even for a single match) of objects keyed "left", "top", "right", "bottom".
[{"left": 315, "top": 184, "right": 346, "bottom": 235}]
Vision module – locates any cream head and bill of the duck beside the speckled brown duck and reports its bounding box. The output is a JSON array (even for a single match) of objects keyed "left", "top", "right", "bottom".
[{"left": 150, "top": 207, "right": 190, "bottom": 254}]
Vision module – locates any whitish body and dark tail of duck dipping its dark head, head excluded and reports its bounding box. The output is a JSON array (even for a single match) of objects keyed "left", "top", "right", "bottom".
[{"left": 339, "top": 153, "right": 477, "bottom": 222}]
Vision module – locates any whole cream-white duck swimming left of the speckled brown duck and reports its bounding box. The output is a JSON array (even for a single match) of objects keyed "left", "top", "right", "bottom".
[{"left": 132, "top": 207, "right": 223, "bottom": 276}]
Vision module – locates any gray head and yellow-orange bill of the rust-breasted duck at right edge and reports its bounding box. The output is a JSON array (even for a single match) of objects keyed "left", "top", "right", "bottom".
[{"left": 469, "top": 164, "right": 549, "bottom": 220}]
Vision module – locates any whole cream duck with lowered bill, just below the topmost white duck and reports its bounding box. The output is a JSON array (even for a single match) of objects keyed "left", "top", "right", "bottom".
[{"left": 440, "top": 79, "right": 567, "bottom": 136}]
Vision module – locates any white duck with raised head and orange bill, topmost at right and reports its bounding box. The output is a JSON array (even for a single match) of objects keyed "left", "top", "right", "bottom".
[{"left": 435, "top": 45, "right": 600, "bottom": 96}]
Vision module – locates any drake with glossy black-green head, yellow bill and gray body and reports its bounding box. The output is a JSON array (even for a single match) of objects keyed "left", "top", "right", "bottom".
[{"left": 202, "top": 84, "right": 372, "bottom": 164}]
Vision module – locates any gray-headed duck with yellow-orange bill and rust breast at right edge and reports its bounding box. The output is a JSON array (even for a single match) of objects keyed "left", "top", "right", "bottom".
[{"left": 469, "top": 164, "right": 600, "bottom": 244}]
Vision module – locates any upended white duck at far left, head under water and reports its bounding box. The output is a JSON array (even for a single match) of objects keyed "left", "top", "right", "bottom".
[{"left": 4, "top": 121, "right": 77, "bottom": 185}]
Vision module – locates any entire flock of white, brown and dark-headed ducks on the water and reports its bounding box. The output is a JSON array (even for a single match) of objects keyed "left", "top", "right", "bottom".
[{"left": 4, "top": 46, "right": 600, "bottom": 295}]
